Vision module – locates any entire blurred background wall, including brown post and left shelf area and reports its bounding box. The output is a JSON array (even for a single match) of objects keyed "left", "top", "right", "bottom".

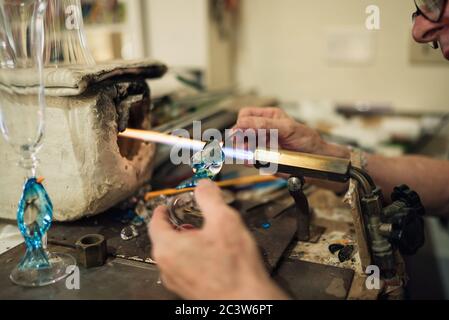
[{"left": 82, "top": 0, "right": 449, "bottom": 109}]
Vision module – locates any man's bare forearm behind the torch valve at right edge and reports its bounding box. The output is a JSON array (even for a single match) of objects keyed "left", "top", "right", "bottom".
[{"left": 366, "top": 155, "right": 449, "bottom": 217}]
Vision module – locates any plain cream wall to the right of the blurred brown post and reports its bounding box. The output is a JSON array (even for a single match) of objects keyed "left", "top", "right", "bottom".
[{"left": 237, "top": 0, "right": 449, "bottom": 109}]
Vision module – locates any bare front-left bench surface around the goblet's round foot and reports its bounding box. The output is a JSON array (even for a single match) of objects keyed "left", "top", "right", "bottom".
[{"left": 0, "top": 245, "right": 176, "bottom": 300}]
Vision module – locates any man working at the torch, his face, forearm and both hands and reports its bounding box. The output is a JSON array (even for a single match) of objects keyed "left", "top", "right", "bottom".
[{"left": 149, "top": 0, "right": 449, "bottom": 299}]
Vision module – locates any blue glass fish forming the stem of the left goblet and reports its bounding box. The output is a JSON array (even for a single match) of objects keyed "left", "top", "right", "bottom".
[{"left": 17, "top": 178, "right": 53, "bottom": 270}]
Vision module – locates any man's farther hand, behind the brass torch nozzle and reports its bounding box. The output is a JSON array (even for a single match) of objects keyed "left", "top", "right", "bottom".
[{"left": 235, "top": 107, "right": 350, "bottom": 158}]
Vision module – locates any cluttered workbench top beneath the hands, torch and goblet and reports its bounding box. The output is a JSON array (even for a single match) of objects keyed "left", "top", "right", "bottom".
[{"left": 0, "top": 101, "right": 378, "bottom": 299}]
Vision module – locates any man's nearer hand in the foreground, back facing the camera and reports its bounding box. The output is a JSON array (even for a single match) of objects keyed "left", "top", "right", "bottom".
[{"left": 149, "top": 180, "right": 287, "bottom": 300}]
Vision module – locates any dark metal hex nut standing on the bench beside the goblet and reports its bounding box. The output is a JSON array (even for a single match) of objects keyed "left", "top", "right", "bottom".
[{"left": 75, "top": 234, "right": 108, "bottom": 268}]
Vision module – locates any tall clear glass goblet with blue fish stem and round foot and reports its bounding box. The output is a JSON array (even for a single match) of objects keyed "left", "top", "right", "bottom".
[{"left": 0, "top": 0, "right": 76, "bottom": 287}]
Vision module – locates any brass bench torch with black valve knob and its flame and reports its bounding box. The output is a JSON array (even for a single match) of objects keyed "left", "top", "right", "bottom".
[{"left": 118, "top": 130, "right": 424, "bottom": 286}]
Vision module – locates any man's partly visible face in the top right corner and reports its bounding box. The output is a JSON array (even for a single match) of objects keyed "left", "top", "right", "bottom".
[{"left": 413, "top": 1, "right": 449, "bottom": 60}]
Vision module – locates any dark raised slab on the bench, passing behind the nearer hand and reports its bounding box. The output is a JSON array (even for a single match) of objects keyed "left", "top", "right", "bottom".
[{"left": 43, "top": 191, "right": 296, "bottom": 270}]
